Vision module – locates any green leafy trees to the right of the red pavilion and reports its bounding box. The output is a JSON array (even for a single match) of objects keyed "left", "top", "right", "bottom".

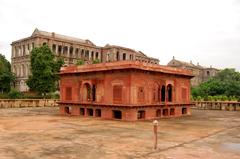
[{"left": 192, "top": 68, "right": 240, "bottom": 98}]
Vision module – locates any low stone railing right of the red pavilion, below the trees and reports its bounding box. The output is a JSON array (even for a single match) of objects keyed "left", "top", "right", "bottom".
[{"left": 193, "top": 101, "right": 240, "bottom": 111}]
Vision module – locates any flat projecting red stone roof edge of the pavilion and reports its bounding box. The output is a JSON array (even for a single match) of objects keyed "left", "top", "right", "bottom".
[{"left": 60, "top": 61, "right": 193, "bottom": 77}]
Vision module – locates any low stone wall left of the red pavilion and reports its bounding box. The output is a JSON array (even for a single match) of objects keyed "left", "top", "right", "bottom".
[{"left": 0, "top": 99, "right": 58, "bottom": 108}]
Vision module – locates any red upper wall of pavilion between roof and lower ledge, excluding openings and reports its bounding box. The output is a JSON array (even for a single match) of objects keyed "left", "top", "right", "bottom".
[{"left": 60, "top": 71, "right": 190, "bottom": 104}]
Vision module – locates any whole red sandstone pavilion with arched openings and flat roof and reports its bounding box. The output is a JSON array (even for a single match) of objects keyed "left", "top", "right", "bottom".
[{"left": 59, "top": 61, "right": 193, "bottom": 121}]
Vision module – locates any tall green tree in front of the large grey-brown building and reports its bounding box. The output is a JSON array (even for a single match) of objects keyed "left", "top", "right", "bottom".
[{"left": 27, "top": 45, "right": 64, "bottom": 98}]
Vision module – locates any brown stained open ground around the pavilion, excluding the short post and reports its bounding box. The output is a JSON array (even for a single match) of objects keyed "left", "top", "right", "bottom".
[{"left": 0, "top": 108, "right": 240, "bottom": 159}]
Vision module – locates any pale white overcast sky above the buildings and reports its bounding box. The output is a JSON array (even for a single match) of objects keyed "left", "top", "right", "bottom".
[{"left": 0, "top": 0, "right": 240, "bottom": 71}]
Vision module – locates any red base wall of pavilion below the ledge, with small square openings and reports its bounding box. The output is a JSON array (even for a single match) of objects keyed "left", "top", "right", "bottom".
[{"left": 60, "top": 105, "right": 191, "bottom": 121}]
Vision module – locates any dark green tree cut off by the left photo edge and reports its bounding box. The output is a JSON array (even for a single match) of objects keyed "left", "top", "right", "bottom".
[{"left": 0, "top": 54, "right": 15, "bottom": 93}]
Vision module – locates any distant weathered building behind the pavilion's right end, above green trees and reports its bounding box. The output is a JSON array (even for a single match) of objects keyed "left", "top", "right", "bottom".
[{"left": 167, "top": 57, "right": 219, "bottom": 87}]
